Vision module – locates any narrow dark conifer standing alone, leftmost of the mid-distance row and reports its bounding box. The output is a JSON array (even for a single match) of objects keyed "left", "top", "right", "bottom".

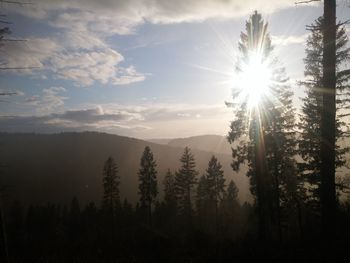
[{"left": 102, "top": 157, "right": 120, "bottom": 227}]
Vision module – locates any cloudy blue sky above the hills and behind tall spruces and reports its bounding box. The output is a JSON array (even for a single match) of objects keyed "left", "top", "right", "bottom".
[{"left": 0, "top": 0, "right": 350, "bottom": 139}]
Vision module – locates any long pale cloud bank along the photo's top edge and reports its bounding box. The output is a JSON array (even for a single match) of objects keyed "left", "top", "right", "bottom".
[{"left": 17, "top": 0, "right": 295, "bottom": 25}]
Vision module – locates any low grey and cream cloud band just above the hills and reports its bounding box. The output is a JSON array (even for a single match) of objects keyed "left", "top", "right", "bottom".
[{"left": 0, "top": 103, "right": 232, "bottom": 138}]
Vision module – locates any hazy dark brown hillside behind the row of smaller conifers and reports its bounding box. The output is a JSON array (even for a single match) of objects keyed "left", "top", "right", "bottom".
[{"left": 0, "top": 132, "right": 250, "bottom": 207}]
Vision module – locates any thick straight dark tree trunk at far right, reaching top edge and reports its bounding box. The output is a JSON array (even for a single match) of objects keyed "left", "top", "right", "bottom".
[{"left": 321, "top": 0, "right": 336, "bottom": 243}]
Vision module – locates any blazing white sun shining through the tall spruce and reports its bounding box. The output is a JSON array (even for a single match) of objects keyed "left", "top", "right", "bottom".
[{"left": 236, "top": 52, "right": 272, "bottom": 109}]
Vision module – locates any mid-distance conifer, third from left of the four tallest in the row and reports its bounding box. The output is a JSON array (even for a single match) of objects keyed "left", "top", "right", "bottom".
[{"left": 175, "top": 147, "right": 198, "bottom": 223}]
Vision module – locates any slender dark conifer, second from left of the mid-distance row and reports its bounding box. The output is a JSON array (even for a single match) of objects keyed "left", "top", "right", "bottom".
[{"left": 138, "top": 146, "right": 158, "bottom": 226}]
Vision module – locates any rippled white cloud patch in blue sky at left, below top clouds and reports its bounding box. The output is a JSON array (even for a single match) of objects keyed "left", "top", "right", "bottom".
[{"left": 1, "top": 35, "right": 145, "bottom": 86}]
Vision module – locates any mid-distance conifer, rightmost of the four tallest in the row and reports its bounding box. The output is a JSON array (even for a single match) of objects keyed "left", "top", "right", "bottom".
[{"left": 206, "top": 155, "right": 225, "bottom": 234}]
